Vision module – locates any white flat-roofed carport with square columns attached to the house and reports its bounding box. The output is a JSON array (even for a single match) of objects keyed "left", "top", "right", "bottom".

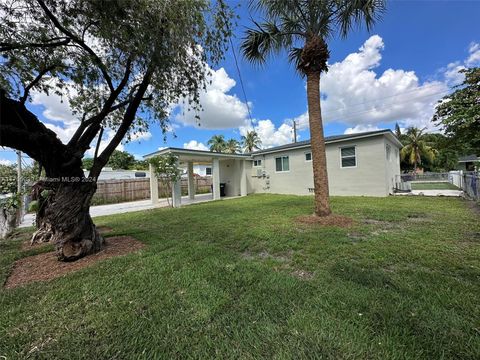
[{"left": 144, "top": 147, "right": 250, "bottom": 207}]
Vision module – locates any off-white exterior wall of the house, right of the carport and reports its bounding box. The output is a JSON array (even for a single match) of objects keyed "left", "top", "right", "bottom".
[{"left": 247, "top": 135, "right": 400, "bottom": 196}]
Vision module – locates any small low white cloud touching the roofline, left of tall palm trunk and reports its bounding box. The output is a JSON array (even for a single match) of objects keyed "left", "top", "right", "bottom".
[{"left": 239, "top": 119, "right": 299, "bottom": 148}]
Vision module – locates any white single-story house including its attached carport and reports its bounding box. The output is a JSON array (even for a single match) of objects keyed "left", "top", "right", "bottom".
[{"left": 144, "top": 130, "right": 402, "bottom": 206}]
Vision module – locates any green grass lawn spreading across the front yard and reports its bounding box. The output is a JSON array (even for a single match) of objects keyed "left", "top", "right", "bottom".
[{"left": 0, "top": 195, "right": 480, "bottom": 359}]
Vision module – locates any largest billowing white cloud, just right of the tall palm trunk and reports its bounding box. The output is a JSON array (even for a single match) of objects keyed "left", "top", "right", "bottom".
[{"left": 316, "top": 35, "right": 448, "bottom": 128}]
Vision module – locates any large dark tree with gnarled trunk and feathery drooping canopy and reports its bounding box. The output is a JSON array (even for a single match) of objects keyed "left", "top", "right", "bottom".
[{"left": 0, "top": 0, "right": 231, "bottom": 260}]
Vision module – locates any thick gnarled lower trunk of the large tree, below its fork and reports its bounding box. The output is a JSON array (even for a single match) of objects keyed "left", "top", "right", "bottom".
[{"left": 32, "top": 177, "right": 104, "bottom": 261}]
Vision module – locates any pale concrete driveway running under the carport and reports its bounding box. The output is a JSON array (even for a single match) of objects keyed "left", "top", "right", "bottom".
[{"left": 19, "top": 193, "right": 213, "bottom": 227}]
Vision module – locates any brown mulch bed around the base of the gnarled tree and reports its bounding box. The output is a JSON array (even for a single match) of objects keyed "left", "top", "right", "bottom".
[{"left": 5, "top": 236, "right": 145, "bottom": 289}]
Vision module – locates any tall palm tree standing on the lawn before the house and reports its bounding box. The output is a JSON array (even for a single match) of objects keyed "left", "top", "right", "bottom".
[{"left": 241, "top": 0, "right": 385, "bottom": 216}]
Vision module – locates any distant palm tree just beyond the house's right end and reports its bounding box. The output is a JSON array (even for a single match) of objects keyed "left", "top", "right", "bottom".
[{"left": 400, "top": 127, "right": 436, "bottom": 174}]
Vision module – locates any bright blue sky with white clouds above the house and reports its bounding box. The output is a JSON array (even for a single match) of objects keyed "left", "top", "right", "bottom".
[{"left": 0, "top": 0, "right": 480, "bottom": 162}]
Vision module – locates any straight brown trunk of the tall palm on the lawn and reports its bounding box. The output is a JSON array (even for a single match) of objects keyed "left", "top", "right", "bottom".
[{"left": 307, "top": 71, "right": 331, "bottom": 216}]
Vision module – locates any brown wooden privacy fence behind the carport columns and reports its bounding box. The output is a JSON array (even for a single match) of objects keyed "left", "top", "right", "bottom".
[{"left": 93, "top": 177, "right": 212, "bottom": 204}]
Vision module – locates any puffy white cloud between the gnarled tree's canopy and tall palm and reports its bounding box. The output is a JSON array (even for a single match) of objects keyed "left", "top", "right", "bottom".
[{"left": 175, "top": 68, "right": 248, "bottom": 129}]
